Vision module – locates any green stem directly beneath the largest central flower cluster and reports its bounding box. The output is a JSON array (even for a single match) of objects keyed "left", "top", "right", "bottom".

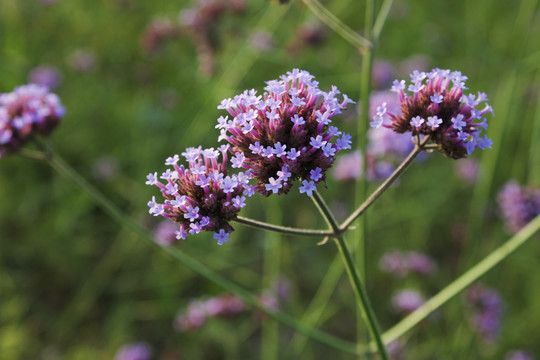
[{"left": 313, "top": 191, "right": 388, "bottom": 360}]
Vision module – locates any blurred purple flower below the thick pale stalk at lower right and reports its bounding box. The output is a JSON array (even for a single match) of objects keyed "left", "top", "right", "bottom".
[{"left": 466, "top": 283, "right": 504, "bottom": 343}]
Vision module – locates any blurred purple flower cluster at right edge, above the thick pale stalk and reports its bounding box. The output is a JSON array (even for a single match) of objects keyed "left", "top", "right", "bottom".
[{"left": 498, "top": 180, "right": 540, "bottom": 233}]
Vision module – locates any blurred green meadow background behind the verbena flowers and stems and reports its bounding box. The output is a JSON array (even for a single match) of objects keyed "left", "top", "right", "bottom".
[{"left": 0, "top": 0, "right": 540, "bottom": 360}]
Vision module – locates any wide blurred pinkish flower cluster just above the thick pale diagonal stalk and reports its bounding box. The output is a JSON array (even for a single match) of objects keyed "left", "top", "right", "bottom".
[{"left": 379, "top": 250, "right": 437, "bottom": 278}]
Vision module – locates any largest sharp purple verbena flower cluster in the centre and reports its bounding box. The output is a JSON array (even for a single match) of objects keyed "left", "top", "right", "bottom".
[{"left": 216, "top": 69, "right": 352, "bottom": 196}]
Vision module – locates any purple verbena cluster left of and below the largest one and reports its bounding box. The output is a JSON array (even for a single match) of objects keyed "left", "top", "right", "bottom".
[{"left": 146, "top": 145, "right": 254, "bottom": 245}]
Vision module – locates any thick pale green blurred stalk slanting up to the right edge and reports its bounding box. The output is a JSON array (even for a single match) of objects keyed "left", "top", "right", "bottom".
[{"left": 380, "top": 215, "right": 540, "bottom": 346}]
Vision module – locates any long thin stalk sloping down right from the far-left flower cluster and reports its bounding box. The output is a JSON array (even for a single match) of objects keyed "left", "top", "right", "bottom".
[{"left": 47, "top": 154, "right": 366, "bottom": 356}]
